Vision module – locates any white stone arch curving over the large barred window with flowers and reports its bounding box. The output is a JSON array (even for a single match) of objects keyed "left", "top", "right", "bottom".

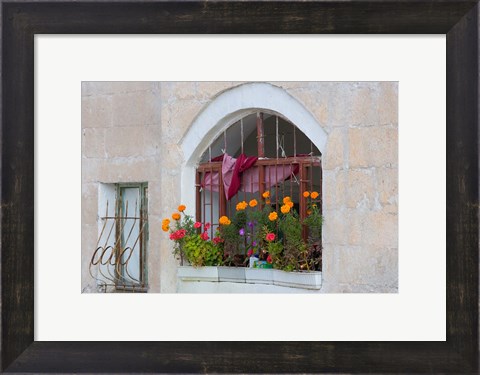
[{"left": 179, "top": 82, "right": 327, "bottom": 214}]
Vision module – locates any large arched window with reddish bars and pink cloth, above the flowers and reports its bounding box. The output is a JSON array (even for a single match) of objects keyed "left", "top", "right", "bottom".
[{"left": 195, "top": 111, "right": 322, "bottom": 269}]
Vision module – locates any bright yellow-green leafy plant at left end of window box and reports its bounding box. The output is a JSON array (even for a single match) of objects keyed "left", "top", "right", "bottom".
[{"left": 183, "top": 234, "right": 222, "bottom": 267}]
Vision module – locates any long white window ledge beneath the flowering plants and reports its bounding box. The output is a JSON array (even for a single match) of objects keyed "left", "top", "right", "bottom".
[{"left": 177, "top": 266, "right": 322, "bottom": 291}]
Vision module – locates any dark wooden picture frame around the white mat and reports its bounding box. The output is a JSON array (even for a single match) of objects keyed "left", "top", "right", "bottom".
[{"left": 0, "top": 0, "right": 479, "bottom": 374}]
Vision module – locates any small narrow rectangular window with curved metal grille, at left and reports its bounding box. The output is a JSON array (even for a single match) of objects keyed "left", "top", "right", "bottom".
[{"left": 90, "top": 183, "right": 148, "bottom": 292}]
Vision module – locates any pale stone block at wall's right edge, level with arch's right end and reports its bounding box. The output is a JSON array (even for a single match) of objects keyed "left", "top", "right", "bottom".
[{"left": 348, "top": 126, "right": 398, "bottom": 168}]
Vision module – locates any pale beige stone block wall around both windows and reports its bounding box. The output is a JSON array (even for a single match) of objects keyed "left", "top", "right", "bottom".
[{"left": 82, "top": 82, "right": 398, "bottom": 292}]
